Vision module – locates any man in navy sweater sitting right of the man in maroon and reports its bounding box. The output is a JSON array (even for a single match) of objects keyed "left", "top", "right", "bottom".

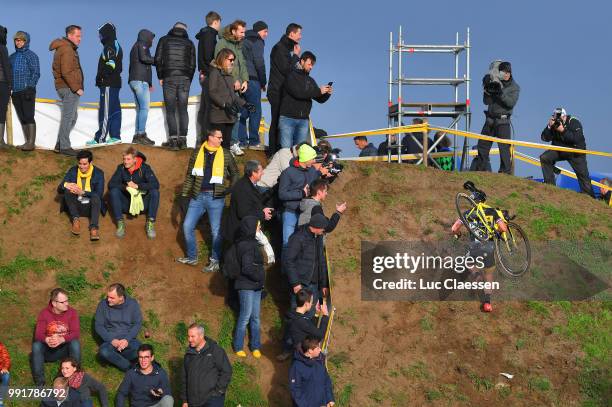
[{"left": 95, "top": 283, "right": 142, "bottom": 372}]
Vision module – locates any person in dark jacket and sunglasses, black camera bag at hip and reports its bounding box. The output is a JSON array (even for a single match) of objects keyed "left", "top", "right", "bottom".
[{"left": 204, "top": 48, "right": 255, "bottom": 150}]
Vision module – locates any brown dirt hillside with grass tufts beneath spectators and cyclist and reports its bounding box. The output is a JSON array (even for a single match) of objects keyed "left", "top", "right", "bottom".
[{"left": 0, "top": 146, "right": 612, "bottom": 406}]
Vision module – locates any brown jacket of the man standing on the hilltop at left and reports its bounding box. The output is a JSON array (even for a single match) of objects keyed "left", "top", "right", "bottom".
[{"left": 49, "top": 37, "right": 85, "bottom": 92}]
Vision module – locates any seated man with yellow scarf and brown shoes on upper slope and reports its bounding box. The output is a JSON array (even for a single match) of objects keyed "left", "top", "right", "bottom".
[{"left": 57, "top": 150, "right": 106, "bottom": 240}]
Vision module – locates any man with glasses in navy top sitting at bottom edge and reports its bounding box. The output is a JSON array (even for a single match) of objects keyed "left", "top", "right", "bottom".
[{"left": 115, "top": 343, "right": 174, "bottom": 407}]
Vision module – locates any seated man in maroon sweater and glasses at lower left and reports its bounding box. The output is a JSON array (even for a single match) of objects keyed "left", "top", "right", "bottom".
[{"left": 32, "top": 288, "right": 81, "bottom": 386}]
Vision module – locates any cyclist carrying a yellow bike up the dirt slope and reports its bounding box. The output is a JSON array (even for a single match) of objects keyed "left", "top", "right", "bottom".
[{"left": 451, "top": 181, "right": 508, "bottom": 312}]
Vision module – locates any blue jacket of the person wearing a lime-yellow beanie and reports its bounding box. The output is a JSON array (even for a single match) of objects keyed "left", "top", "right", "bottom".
[{"left": 278, "top": 158, "right": 321, "bottom": 211}]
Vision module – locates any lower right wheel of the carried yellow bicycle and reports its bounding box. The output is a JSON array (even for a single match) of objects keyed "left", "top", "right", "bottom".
[{"left": 495, "top": 222, "right": 531, "bottom": 277}]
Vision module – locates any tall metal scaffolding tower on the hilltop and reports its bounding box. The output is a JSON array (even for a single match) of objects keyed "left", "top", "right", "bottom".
[{"left": 387, "top": 26, "right": 471, "bottom": 167}]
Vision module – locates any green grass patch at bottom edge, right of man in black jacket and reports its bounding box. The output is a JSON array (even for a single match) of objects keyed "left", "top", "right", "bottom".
[{"left": 225, "top": 361, "right": 268, "bottom": 407}]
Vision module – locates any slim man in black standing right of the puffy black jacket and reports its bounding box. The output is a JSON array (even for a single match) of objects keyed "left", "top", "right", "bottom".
[{"left": 196, "top": 11, "right": 221, "bottom": 140}]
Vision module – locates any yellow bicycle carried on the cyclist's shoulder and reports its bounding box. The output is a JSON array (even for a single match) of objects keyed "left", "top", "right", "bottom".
[{"left": 455, "top": 181, "right": 531, "bottom": 277}]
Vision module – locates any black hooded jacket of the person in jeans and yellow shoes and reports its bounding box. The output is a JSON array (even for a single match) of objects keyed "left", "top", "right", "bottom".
[{"left": 234, "top": 215, "right": 266, "bottom": 291}]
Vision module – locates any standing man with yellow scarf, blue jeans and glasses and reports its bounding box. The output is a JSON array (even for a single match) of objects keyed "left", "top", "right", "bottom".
[{"left": 177, "top": 127, "right": 239, "bottom": 272}]
